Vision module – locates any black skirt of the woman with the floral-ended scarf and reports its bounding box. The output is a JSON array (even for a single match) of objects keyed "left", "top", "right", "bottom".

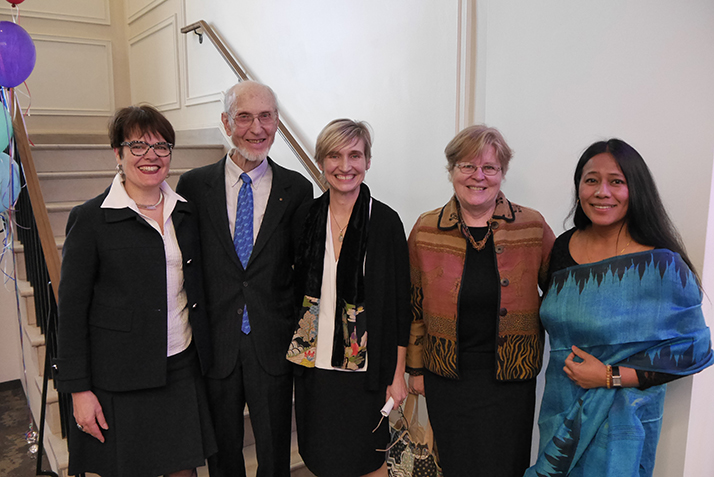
[{"left": 295, "top": 368, "right": 389, "bottom": 477}]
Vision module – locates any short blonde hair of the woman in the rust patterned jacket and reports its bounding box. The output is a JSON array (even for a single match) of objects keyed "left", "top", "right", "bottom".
[{"left": 444, "top": 124, "right": 513, "bottom": 175}]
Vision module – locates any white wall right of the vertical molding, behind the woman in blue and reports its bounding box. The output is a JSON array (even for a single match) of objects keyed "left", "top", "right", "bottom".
[{"left": 478, "top": 0, "right": 714, "bottom": 266}]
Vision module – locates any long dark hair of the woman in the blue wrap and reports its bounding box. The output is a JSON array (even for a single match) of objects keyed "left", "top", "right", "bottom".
[{"left": 568, "top": 139, "right": 699, "bottom": 278}]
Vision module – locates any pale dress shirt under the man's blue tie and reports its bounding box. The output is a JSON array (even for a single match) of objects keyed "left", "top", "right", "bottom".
[{"left": 226, "top": 153, "right": 273, "bottom": 244}]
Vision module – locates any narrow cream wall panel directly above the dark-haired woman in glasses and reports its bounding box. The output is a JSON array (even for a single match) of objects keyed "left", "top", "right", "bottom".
[{"left": 129, "top": 14, "right": 181, "bottom": 111}]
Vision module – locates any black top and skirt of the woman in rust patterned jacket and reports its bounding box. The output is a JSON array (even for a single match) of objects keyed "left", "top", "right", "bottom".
[{"left": 424, "top": 227, "right": 536, "bottom": 477}]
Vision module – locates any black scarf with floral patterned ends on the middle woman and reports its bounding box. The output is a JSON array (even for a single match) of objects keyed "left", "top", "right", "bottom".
[{"left": 286, "top": 184, "right": 371, "bottom": 370}]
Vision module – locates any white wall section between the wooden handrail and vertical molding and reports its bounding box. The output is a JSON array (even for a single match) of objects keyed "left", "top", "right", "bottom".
[{"left": 176, "top": 0, "right": 459, "bottom": 229}]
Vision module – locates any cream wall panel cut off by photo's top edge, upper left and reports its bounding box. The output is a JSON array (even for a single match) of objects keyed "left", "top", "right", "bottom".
[{"left": 0, "top": 0, "right": 111, "bottom": 25}]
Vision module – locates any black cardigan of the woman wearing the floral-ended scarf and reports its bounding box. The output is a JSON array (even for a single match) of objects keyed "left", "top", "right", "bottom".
[{"left": 293, "top": 198, "right": 412, "bottom": 391}]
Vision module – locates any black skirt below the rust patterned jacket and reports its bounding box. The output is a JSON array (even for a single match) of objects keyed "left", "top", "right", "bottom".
[{"left": 424, "top": 367, "right": 536, "bottom": 477}]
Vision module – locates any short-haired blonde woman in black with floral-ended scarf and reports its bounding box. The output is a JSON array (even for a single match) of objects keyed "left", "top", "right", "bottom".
[{"left": 288, "top": 119, "right": 411, "bottom": 477}]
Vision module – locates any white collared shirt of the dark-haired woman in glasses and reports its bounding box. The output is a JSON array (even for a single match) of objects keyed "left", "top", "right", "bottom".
[{"left": 101, "top": 174, "right": 192, "bottom": 356}]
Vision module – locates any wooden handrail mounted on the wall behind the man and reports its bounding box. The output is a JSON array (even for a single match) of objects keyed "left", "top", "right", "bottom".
[{"left": 181, "top": 20, "right": 327, "bottom": 192}]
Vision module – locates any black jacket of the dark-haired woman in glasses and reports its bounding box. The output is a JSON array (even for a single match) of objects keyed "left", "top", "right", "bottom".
[{"left": 55, "top": 189, "right": 211, "bottom": 393}]
